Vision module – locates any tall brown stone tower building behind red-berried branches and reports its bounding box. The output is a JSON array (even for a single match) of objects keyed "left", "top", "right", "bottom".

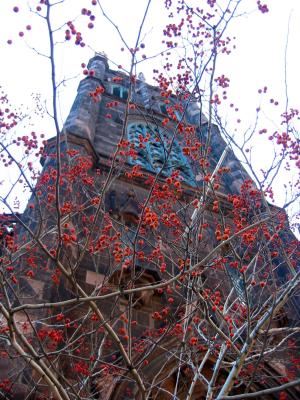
[{"left": 1, "top": 54, "right": 299, "bottom": 400}]
